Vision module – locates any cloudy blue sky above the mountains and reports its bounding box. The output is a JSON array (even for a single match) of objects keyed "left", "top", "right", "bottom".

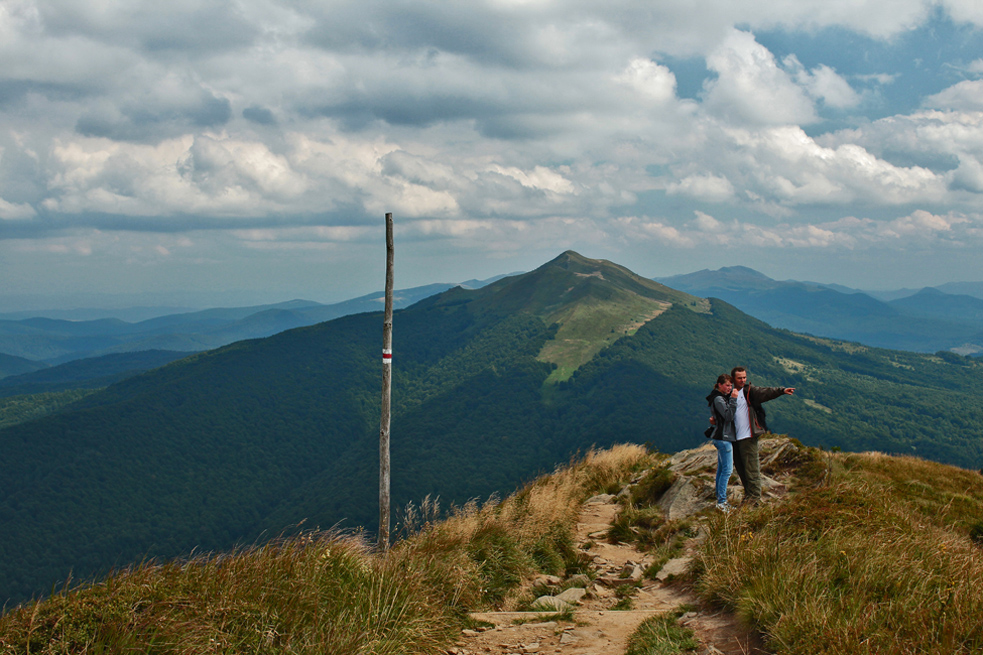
[{"left": 0, "top": 0, "right": 983, "bottom": 311}]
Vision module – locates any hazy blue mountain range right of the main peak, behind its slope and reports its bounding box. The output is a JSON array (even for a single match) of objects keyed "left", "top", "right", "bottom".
[{"left": 658, "top": 266, "right": 983, "bottom": 354}]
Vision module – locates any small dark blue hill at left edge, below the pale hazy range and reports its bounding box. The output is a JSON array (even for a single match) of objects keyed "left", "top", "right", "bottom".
[{"left": 0, "top": 350, "right": 188, "bottom": 397}]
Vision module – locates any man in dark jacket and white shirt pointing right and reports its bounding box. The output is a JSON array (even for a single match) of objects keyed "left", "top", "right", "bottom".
[{"left": 730, "top": 366, "right": 795, "bottom": 505}]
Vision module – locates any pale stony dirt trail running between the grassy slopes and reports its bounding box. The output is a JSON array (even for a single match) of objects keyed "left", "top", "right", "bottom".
[{"left": 449, "top": 452, "right": 765, "bottom": 655}]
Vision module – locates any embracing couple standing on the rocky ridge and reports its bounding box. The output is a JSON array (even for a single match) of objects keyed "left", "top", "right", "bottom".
[{"left": 706, "top": 366, "right": 795, "bottom": 512}]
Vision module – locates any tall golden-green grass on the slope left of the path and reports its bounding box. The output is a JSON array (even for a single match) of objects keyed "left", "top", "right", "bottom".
[{"left": 0, "top": 446, "right": 652, "bottom": 655}]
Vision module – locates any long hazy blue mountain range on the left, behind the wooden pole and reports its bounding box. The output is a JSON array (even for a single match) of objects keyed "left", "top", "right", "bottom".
[{"left": 0, "top": 276, "right": 504, "bottom": 365}]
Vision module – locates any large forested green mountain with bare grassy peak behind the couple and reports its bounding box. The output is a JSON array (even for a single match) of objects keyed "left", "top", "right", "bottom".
[{"left": 0, "top": 252, "right": 983, "bottom": 599}]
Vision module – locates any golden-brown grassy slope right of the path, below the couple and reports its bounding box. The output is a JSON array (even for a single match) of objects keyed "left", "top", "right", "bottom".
[{"left": 699, "top": 454, "right": 983, "bottom": 655}]
